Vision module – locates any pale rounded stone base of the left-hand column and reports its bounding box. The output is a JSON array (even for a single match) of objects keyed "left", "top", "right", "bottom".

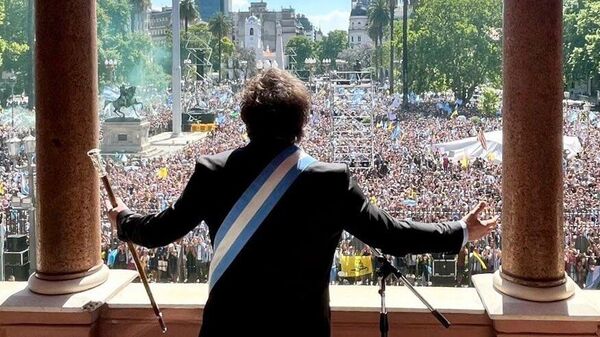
[{"left": 28, "top": 264, "right": 109, "bottom": 295}]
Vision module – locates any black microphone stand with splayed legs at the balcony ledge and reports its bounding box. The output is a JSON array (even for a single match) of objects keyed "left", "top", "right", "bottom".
[{"left": 371, "top": 248, "right": 450, "bottom": 337}]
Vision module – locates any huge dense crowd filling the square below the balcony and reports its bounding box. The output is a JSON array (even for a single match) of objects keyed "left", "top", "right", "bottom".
[{"left": 0, "top": 78, "right": 600, "bottom": 288}]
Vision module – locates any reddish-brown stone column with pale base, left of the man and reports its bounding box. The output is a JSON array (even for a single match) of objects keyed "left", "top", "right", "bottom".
[{"left": 29, "top": 0, "right": 108, "bottom": 294}]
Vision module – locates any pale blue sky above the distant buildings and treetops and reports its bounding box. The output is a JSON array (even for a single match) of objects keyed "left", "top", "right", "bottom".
[{"left": 152, "top": 0, "right": 350, "bottom": 34}]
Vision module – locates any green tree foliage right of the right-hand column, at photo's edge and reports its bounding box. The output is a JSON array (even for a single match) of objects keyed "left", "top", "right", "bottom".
[{"left": 563, "top": 0, "right": 600, "bottom": 87}]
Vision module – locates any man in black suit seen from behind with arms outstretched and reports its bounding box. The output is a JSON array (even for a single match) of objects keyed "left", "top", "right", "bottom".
[{"left": 109, "top": 69, "right": 495, "bottom": 337}]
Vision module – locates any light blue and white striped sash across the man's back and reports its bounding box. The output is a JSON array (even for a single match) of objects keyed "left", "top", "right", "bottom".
[{"left": 208, "top": 145, "right": 316, "bottom": 291}]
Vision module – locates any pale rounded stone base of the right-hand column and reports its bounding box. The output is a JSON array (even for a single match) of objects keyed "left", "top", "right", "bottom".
[{"left": 494, "top": 271, "right": 577, "bottom": 302}]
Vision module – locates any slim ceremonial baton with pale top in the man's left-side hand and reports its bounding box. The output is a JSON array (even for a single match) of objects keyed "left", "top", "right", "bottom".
[{"left": 88, "top": 149, "right": 167, "bottom": 333}]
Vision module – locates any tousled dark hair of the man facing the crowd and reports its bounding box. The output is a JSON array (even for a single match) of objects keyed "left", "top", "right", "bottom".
[{"left": 241, "top": 69, "right": 310, "bottom": 143}]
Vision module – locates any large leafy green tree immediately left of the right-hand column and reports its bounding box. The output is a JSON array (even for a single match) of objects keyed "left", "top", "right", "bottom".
[{"left": 404, "top": 0, "right": 502, "bottom": 99}]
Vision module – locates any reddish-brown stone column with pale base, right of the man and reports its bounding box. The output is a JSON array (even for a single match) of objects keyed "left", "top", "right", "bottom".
[{"left": 494, "top": 0, "right": 574, "bottom": 301}]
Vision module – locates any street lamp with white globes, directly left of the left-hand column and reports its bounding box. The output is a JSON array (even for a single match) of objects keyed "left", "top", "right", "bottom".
[{"left": 6, "top": 135, "right": 36, "bottom": 275}]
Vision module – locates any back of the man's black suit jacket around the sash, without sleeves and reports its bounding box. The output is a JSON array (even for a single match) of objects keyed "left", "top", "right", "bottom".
[{"left": 197, "top": 138, "right": 347, "bottom": 336}]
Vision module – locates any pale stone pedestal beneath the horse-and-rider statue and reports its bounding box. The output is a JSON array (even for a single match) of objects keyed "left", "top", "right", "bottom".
[{"left": 101, "top": 118, "right": 150, "bottom": 153}]
